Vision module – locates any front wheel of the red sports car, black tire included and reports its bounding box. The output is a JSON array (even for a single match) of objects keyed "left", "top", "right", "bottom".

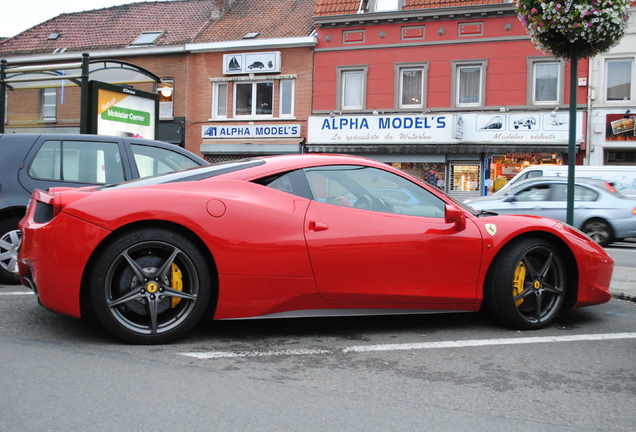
[{"left": 484, "top": 238, "right": 567, "bottom": 330}]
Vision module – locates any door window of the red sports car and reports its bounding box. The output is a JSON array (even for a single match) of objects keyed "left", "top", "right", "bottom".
[{"left": 305, "top": 166, "right": 445, "bottom": 218}]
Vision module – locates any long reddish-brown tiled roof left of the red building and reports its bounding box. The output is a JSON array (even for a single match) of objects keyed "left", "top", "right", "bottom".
[{"left": 0, "top": 0, "right": 315, "bottom": 58}]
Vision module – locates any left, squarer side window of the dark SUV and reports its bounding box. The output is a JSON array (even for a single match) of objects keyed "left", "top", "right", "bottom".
[{"left": 29, "top": 140, "right": 124, "bottom": 184}]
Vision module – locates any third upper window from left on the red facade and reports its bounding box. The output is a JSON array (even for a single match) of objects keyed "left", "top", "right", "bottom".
[{"left": 451, "top": 60, "right": 487, "bottom": 107}]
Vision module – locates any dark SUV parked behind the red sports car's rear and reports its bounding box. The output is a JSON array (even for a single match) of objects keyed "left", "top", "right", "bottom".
[{"left": 0, "top": 134, "right": 208, "bottom": 284}]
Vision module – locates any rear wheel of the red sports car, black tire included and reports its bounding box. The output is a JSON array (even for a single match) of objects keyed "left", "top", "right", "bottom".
[{"left": 89, "top": 229, "right": 211, "bottom": 345}]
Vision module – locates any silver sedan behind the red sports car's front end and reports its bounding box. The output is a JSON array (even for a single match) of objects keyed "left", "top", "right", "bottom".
[{"left": 467, "top": 177, "right": 636, "bottom": 246}]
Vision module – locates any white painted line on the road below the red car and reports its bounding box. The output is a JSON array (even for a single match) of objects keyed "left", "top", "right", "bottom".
[{"left": 179, "top": 332, "right": 636, "bottom": 360}]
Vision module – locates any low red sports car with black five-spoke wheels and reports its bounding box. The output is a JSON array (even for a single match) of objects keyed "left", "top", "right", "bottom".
[{"left": 19, "top": 155, "right": 614, "bottom": 344}]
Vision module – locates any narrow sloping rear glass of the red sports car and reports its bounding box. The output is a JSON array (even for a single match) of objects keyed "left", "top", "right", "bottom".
[{"left": 99, "top": 159, "right": 265, "bottom": 190}]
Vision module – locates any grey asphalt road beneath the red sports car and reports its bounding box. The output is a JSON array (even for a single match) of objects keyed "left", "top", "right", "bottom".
[{"left": 0, "top": 278, "right": 636, "bottom": 432}]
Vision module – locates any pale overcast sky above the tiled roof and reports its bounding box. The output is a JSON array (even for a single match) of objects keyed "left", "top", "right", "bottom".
[{"left": 0, "top": 0, "right": 154, "bottom": 37}]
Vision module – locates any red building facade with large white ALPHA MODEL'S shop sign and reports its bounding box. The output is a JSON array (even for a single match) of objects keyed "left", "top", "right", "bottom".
[{"left": 306, "top": 0, "right": 588, "bottom": 197}]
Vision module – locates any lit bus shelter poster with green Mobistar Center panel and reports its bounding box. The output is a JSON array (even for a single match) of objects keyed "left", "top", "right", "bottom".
[{"left": 91, "top": 81, "right": 159, "bottom": 139}]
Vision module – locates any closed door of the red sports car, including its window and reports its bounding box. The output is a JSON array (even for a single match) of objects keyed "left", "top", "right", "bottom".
[{"left": 305, "top": 167, "right": 482, "bottom": 308}]
